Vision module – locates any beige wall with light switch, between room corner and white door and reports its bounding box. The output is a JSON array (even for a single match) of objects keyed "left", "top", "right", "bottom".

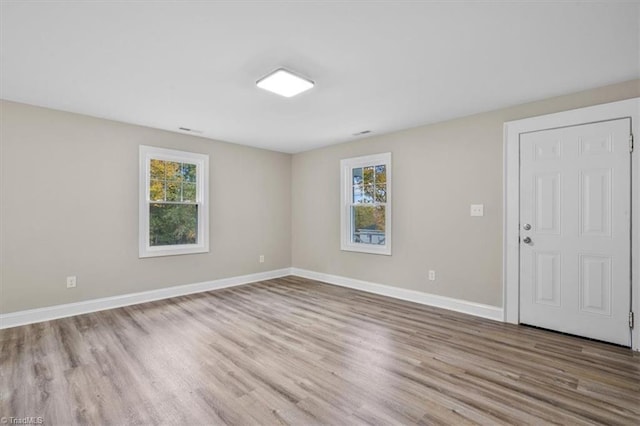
[{"left": 292, "top": 80, "right": 640, "bottom": 306}]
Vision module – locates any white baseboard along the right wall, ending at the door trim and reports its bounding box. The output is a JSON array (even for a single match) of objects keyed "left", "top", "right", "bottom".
[{"left": 291, "top": 268, "right": 504, "bottom": 321}]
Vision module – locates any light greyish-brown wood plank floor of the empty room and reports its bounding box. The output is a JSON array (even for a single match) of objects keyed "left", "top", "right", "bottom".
[{"left": 0, "top": 277, "right": 640, "bottom": 425}]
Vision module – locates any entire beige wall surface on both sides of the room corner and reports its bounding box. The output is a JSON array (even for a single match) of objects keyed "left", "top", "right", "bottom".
[{"left": 5, "top": 80, "right": 640, "bottom": 313}]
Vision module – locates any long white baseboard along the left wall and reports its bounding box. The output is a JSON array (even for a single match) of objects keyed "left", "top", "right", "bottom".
[{"left": 0, "top": 268, "right": 291, "bottom": 329}]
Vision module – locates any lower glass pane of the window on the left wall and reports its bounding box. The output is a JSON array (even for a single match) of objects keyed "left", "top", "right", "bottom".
[{"left": 149, "top": 203, "right": 198, "bottom": 246}]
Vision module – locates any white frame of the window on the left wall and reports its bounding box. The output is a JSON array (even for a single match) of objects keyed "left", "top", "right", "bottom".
[{"left": 138, "top": 145, "right": 209, "bottom": 258}]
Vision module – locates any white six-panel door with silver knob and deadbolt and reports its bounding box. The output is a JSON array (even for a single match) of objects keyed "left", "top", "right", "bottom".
[{"left": 520, "top": 118, "right": 631, "bottom": 346}]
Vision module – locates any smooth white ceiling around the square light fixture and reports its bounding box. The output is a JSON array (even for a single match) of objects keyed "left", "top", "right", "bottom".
[{"left": 0, "top": 0, "right": 640, "bottom": 153}]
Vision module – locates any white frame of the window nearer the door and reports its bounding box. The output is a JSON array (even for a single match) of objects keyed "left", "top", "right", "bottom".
[{"left": 340, "top": 152, "right": 392, "bottom": 256}]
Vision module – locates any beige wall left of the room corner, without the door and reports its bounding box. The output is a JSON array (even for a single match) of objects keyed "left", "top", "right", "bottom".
[{"left": 0, "top": 102, "right": 291, "bottom": 313}]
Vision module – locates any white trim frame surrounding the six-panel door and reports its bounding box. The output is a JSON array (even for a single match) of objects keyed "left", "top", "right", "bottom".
[{"left": 502, "top": 97, "right": 640, "bottom": 351}]
